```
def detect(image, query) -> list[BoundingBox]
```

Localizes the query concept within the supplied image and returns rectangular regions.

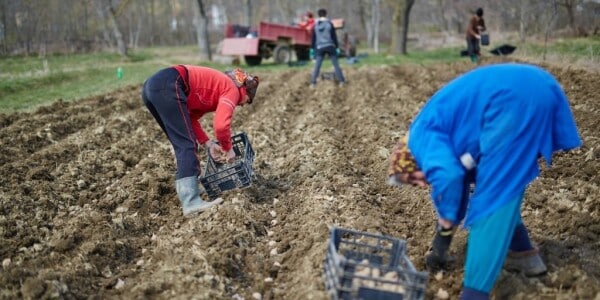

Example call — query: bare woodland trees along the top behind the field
[0,0,600,59]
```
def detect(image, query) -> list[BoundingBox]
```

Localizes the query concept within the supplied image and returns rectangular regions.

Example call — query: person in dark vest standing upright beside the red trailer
[310,9,346,88]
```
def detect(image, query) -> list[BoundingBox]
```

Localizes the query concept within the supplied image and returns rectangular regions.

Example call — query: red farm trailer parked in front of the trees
[221,19,344,66]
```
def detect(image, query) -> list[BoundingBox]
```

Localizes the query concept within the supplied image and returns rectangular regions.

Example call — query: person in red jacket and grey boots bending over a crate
[142,65,259,216]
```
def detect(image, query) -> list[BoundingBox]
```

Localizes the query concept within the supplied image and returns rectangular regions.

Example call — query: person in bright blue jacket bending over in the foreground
[388,63,582,299]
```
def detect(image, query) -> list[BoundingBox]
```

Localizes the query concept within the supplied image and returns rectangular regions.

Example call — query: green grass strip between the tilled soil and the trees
[0,37,600,113]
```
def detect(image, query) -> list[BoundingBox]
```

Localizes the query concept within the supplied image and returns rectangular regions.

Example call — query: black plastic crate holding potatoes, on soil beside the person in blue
[323,227,428,300]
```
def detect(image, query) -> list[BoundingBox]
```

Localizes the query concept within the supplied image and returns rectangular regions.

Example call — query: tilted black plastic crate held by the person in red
[200,132,254,199]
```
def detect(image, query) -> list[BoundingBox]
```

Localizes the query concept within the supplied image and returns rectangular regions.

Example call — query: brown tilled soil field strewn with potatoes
[0,57,600,299]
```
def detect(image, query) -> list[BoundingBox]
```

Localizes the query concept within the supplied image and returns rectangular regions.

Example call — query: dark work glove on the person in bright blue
[425,224,455,272]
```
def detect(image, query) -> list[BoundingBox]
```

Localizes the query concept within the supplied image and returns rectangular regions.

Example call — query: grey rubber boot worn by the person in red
[175,176,223,216]
